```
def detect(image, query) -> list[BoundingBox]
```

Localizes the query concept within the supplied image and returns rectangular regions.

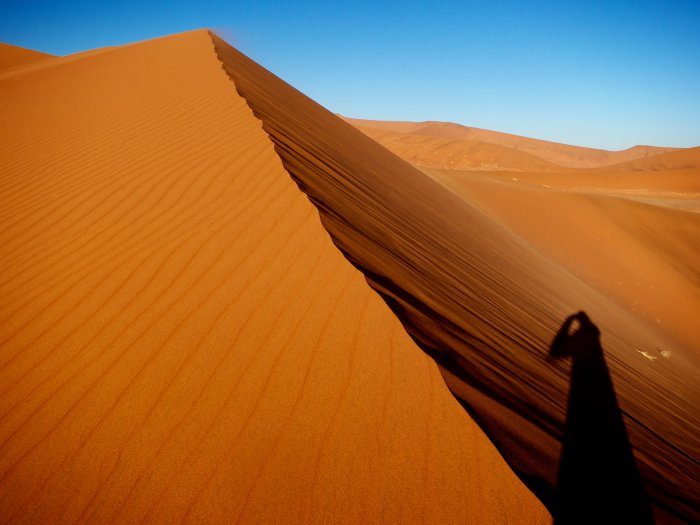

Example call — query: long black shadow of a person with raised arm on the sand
[550,312,654,525]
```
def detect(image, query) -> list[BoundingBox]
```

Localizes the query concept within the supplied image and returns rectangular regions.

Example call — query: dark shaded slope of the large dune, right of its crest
[214,38,699,519]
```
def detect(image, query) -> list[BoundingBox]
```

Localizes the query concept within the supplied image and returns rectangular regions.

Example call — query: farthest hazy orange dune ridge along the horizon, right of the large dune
[343,117,674,168]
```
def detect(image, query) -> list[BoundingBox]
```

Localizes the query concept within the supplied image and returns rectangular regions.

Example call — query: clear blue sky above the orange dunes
[0,0,700,149]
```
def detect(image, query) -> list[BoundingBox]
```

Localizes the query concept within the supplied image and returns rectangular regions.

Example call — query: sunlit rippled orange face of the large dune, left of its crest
[0,31,548,523]
